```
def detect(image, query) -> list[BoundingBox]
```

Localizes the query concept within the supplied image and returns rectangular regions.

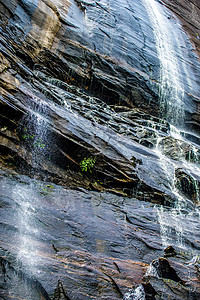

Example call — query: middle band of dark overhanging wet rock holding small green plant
[1,76,199,204]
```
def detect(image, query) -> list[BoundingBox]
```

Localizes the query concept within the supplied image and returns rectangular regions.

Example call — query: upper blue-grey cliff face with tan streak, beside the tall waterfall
[1,1,199,124]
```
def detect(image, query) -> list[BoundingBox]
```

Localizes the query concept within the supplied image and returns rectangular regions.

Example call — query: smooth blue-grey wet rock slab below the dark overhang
[0,172,200,299]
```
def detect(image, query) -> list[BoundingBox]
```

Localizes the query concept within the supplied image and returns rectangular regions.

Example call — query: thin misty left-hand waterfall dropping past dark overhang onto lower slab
[10,97,50,300]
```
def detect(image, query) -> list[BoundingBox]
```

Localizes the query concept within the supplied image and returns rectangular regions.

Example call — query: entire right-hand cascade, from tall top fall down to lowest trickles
[143,0,200,248]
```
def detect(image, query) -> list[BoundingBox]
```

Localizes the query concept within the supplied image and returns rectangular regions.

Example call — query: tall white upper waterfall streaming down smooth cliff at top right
[144,0,191,126]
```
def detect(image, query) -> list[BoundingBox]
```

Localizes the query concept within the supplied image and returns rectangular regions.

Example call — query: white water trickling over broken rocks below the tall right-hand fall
[155,128,200,249]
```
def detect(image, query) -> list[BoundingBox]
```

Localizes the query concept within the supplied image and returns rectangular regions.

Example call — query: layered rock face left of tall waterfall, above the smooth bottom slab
[1,1,199,203]
